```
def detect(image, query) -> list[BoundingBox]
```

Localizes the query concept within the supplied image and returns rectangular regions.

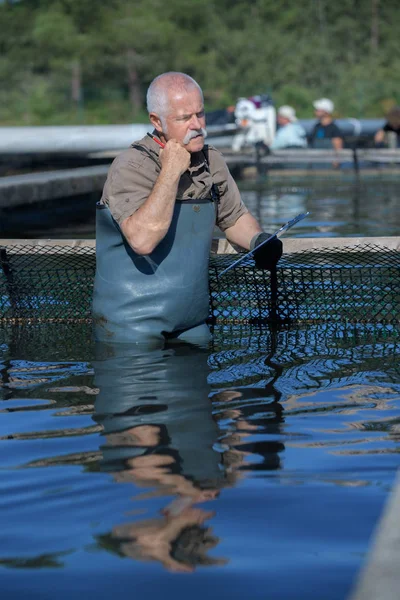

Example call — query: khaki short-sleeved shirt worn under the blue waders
[100,135,248,231]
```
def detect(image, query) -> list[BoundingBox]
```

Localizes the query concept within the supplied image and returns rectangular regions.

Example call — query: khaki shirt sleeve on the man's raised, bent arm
[101,149,158,225]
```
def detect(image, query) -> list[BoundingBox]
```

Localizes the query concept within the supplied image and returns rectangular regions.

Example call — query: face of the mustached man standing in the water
[163,88,206,152]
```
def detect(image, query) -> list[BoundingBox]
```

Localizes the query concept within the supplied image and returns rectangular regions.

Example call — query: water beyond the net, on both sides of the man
[0,171,400,238]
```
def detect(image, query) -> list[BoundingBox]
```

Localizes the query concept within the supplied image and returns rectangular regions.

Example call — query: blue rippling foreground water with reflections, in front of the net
[0,325,400,600]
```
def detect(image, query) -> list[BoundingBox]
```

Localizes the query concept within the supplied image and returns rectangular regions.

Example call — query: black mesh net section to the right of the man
[210,244,400,323]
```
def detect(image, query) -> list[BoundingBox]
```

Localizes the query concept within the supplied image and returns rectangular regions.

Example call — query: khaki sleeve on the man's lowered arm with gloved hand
[209,147,248,231]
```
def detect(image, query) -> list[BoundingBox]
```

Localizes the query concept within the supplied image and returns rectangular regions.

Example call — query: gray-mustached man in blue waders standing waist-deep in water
[93,72,282,344]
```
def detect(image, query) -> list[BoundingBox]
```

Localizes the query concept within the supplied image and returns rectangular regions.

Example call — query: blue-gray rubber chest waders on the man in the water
[93,146,218,343]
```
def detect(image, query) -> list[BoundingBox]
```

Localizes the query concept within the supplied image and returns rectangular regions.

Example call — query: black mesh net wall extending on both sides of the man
[0,243,400,324]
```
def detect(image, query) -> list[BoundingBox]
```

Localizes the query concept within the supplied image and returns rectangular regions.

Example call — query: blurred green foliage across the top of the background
[0,0,400,125]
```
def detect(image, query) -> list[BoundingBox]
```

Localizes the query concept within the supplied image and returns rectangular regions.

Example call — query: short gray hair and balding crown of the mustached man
[146,71,203,117]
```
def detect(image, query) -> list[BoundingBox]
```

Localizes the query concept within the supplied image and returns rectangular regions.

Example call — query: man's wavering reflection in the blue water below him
[94,345,283,572]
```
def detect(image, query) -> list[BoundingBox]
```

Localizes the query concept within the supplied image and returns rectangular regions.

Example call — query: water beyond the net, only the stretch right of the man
[241,174,400,237]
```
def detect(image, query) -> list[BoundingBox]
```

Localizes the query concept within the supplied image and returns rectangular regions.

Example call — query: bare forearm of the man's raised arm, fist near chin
[121,169,180,254]
